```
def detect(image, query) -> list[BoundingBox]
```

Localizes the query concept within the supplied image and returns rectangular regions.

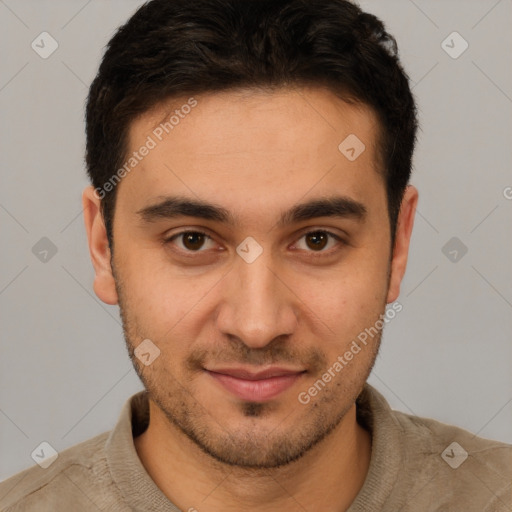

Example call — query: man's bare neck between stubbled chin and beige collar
[134,400,371,512]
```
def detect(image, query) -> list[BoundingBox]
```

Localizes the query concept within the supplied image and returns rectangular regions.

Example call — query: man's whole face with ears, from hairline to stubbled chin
[84,89,412,467]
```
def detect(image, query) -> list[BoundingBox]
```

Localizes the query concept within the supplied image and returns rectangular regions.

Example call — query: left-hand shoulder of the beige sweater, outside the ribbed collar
[0,432,127,512]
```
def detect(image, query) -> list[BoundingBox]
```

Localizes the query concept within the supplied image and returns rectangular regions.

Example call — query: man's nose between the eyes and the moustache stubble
[217,252,297,348]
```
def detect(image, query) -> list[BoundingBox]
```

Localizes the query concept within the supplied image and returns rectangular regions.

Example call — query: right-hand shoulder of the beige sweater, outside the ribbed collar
[391,411,512,511]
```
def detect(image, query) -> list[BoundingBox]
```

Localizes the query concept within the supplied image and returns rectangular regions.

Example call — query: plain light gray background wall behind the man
[0,0,512,480]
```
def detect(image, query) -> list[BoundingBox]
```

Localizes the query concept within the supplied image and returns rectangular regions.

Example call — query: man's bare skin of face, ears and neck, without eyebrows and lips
[83,88,418,512]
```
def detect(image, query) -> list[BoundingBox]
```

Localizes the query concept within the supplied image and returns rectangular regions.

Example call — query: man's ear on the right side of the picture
[386,185,418,304]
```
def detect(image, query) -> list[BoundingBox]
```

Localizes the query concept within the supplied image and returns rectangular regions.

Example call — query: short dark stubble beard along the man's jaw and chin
[116,270,385,470]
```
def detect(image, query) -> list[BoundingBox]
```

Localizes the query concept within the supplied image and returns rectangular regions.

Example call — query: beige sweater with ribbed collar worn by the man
[0,384,512,512]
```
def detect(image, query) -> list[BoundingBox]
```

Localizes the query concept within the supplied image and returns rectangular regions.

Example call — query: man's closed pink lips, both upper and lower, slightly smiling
[206,367,305,402]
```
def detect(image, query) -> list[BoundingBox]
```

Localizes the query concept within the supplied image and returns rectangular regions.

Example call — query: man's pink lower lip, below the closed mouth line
[208,372,302,402]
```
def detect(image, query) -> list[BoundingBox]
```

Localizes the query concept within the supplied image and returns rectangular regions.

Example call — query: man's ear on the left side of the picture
[82,187,117,305]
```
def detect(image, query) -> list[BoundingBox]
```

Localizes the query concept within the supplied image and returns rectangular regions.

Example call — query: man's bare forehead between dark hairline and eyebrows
[121,88,383,216]
